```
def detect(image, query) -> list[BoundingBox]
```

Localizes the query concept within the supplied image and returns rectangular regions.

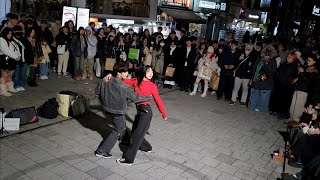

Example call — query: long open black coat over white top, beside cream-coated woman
[177,47,197,81]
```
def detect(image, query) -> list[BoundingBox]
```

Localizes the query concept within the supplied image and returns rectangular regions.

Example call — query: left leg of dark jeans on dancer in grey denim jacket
[97,114,126,153]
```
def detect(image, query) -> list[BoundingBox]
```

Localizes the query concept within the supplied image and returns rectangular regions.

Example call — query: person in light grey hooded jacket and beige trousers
[83,26,98,80]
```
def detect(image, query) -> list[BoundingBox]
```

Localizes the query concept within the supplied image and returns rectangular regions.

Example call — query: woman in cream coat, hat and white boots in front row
[189,46,220,97]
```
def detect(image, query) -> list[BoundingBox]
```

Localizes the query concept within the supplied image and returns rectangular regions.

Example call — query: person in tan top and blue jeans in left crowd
[39,38,52,80]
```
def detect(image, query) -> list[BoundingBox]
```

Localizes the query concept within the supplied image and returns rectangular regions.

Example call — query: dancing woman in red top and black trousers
[107,66,167,165]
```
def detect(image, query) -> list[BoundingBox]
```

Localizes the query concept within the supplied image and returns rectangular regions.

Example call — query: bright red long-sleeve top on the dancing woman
[122,78,167,119]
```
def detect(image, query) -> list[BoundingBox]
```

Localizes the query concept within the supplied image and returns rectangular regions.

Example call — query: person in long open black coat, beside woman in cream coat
[177,38,196,92]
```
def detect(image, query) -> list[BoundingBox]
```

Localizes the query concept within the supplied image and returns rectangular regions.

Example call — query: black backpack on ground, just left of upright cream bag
[38,98,59,119]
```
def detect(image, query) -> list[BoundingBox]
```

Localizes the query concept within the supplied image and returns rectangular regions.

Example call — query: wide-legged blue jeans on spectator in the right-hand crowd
[248,88,271,112]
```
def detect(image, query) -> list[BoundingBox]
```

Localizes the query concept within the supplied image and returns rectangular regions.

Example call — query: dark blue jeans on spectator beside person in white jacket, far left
[13,63,28,87]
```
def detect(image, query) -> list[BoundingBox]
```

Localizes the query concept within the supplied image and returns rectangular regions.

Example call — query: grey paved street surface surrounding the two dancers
[0,74,285,180]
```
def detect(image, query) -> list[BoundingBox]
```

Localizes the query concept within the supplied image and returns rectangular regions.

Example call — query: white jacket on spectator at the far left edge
[0,37,21,61]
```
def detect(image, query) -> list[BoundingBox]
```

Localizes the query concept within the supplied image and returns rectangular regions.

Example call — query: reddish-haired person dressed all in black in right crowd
[269,52,299,120]
